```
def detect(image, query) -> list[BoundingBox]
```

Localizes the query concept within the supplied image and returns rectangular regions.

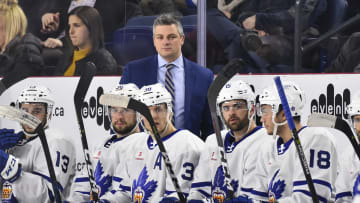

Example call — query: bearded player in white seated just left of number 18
[191,80,268,203]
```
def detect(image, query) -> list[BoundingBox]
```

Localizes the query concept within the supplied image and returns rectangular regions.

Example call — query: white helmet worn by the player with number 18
[260,81,305,117]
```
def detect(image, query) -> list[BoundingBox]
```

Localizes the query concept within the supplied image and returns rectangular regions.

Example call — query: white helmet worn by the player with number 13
[16,85,55,128]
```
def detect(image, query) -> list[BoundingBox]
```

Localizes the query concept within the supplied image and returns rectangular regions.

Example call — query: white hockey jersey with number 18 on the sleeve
[252,127,338,203]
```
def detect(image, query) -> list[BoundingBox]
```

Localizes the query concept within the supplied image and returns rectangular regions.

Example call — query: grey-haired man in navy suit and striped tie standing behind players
[120,14,213,139]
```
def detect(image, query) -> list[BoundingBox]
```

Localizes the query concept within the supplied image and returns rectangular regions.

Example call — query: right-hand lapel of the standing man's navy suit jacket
[184,58,196,129]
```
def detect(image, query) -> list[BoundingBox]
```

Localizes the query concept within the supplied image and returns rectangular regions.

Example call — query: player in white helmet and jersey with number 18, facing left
[250,82,337,203]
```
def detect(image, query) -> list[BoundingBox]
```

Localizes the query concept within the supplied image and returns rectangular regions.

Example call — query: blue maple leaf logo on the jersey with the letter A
[132,166,157,203]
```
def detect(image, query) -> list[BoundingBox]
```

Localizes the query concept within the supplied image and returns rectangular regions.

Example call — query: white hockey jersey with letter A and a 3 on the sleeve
[109,130,204,203]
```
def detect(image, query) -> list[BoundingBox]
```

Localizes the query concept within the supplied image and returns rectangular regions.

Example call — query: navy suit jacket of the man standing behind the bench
[120,55,214,139]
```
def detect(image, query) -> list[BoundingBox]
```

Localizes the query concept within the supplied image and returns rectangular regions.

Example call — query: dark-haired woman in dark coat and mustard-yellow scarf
[55,6,118,76]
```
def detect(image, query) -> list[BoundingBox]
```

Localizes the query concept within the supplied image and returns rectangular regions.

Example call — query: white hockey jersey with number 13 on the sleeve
[3,129,75,203]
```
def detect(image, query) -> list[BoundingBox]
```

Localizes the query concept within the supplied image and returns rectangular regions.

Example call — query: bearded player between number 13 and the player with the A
[69,83,140,202]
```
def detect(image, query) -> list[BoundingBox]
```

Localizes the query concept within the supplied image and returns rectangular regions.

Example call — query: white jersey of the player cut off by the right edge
[335,146,360,203]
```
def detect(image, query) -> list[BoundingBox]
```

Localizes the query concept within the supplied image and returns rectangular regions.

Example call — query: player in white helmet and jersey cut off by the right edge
[336,92,360,203]
